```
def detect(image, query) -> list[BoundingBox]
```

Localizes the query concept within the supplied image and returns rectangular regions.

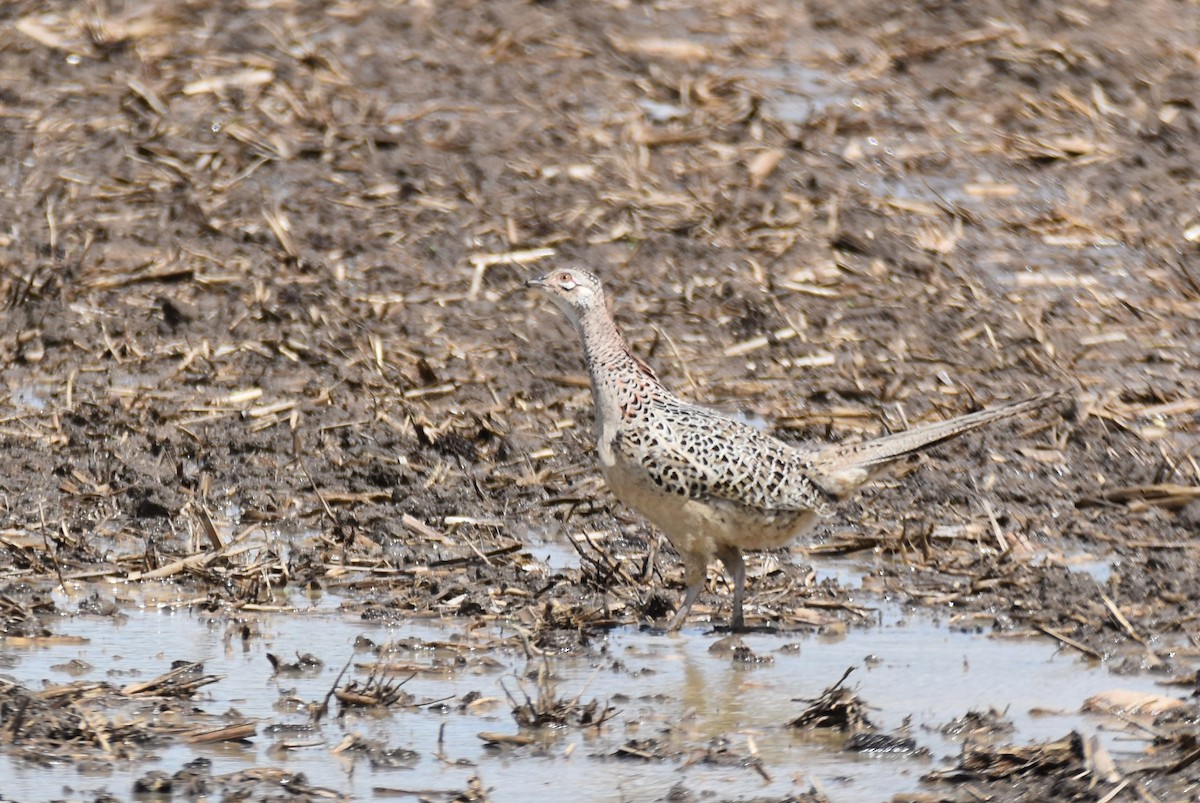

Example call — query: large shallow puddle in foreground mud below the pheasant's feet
[0,597,1156,801]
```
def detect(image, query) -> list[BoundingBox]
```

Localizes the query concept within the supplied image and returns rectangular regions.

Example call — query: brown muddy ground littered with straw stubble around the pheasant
[0,0,1200,801]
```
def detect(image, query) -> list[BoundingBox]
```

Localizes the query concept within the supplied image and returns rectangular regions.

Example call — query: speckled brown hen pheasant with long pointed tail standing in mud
[528,269,1057,629]
